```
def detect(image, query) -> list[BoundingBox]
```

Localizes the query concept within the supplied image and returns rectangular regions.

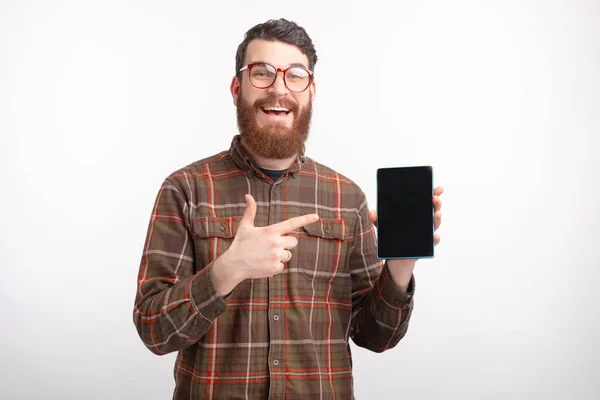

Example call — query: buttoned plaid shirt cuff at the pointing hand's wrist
[189,262,227,322]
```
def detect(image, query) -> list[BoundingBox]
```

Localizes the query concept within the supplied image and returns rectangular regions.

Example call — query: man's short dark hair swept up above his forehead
[235,18,317,79]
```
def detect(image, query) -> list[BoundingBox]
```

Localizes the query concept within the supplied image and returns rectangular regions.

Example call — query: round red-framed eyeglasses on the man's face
[240,63,313,93]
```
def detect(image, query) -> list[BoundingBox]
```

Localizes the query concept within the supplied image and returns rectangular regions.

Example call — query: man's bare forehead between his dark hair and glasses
[244,39,308,68]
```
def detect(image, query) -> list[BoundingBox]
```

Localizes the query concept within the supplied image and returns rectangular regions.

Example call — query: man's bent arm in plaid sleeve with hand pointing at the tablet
[133,189,319,354]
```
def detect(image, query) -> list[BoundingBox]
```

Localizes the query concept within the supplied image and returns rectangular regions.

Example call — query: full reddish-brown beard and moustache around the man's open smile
[236,92,312,160]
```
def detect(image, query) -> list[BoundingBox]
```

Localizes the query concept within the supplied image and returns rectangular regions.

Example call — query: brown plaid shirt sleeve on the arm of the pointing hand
[133,179,227,354]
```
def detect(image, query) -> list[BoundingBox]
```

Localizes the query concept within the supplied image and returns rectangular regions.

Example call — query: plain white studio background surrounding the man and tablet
[0,0,600,400]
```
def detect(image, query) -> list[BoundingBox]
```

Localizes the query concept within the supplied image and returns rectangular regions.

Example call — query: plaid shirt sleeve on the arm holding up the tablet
[349,194,415,353]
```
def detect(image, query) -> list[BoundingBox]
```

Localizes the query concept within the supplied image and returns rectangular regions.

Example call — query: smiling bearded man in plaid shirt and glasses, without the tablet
[134,19,442,399]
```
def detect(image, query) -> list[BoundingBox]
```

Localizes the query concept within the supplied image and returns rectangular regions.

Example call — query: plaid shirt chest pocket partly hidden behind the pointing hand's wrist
[192,217,242,270]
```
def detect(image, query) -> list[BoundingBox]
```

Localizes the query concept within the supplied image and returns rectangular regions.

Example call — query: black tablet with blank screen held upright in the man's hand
[377,166,433,259]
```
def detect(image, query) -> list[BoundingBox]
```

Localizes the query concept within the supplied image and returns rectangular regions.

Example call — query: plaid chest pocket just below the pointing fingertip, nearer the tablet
[298,219,353,281]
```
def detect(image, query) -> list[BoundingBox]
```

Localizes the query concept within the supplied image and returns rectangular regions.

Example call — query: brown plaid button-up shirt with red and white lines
[133,136,414,400]
